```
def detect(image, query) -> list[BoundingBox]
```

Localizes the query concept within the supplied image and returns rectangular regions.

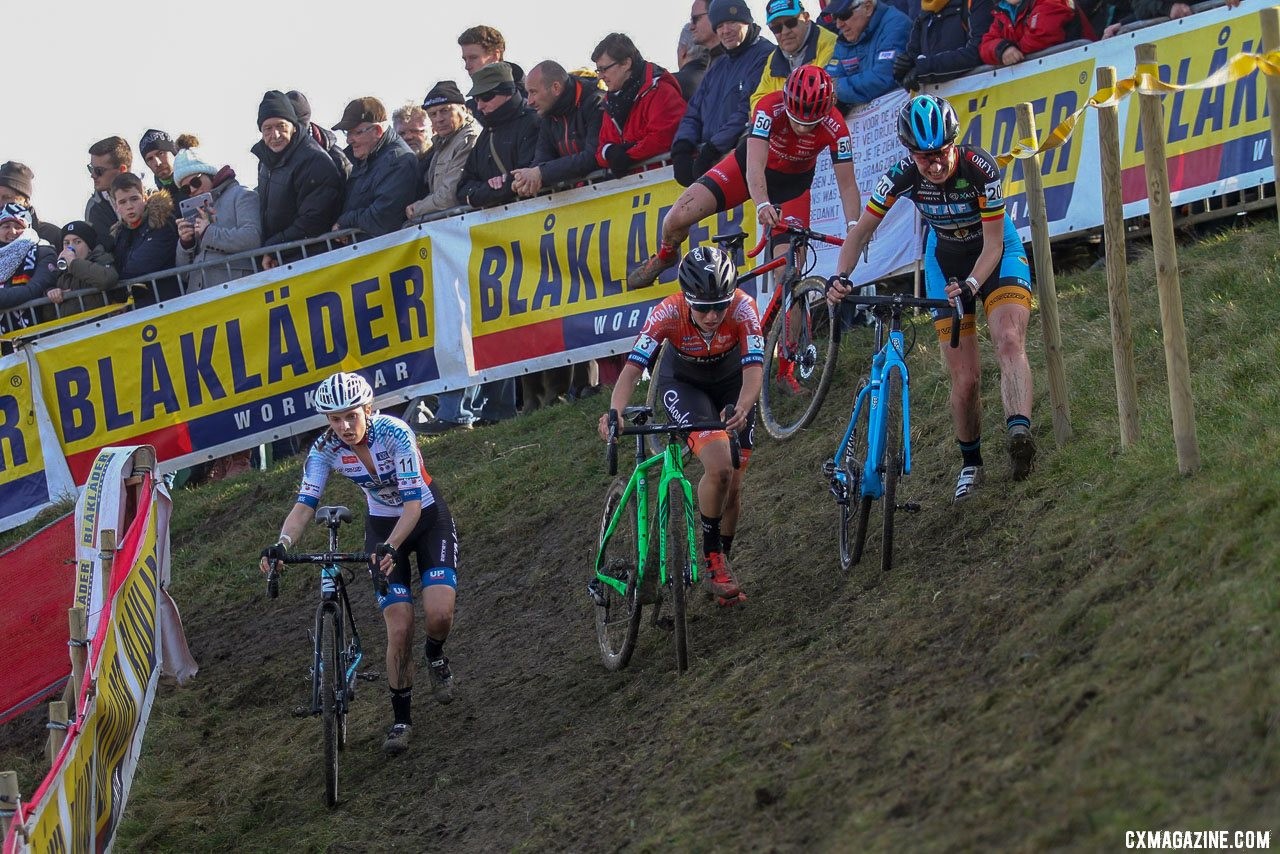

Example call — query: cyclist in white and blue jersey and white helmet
[261,373,458,755]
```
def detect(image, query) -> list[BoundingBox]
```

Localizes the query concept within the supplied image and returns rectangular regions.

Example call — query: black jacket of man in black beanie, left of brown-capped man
[251,132,343,246]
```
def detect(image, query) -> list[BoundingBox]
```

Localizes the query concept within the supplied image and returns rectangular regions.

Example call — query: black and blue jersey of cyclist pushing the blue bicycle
[867,145,1005,246]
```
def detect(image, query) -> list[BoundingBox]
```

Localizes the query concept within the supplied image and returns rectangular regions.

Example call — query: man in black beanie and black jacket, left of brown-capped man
[252,90,343,270]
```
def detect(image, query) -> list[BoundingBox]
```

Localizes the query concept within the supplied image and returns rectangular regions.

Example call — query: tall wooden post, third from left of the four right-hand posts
[1134,44,1199,475]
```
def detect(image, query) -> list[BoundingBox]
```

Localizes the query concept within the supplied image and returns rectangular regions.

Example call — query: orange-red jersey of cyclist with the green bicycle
[627,291,764,383]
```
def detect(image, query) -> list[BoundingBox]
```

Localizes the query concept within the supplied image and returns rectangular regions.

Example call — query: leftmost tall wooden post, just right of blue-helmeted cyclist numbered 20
[1015,101,1071,446]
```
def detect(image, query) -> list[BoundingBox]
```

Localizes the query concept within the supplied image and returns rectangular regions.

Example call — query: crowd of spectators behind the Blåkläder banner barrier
[0,0,1238,429]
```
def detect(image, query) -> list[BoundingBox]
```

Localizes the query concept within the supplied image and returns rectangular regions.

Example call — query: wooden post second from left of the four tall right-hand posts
[1097,65,1139,448]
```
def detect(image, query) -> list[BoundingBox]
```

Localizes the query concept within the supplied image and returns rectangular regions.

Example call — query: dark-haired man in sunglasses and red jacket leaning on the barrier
[591,32,686,175]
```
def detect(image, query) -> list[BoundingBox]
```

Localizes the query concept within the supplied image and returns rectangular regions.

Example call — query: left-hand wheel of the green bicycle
[593,478,644,670]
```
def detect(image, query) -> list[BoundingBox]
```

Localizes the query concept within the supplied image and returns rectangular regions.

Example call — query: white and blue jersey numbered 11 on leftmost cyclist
[298,414,433,516]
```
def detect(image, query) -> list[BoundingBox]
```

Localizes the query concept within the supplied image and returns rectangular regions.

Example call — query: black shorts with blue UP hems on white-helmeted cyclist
[365,483,458,608]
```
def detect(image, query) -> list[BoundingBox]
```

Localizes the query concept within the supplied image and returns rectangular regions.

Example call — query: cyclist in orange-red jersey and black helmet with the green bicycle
[600,247,764,606]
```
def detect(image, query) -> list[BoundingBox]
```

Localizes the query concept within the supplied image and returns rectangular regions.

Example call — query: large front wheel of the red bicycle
[760,275,838,439]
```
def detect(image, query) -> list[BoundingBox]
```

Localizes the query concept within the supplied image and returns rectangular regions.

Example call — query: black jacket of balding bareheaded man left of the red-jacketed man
[534,74,604,187]
